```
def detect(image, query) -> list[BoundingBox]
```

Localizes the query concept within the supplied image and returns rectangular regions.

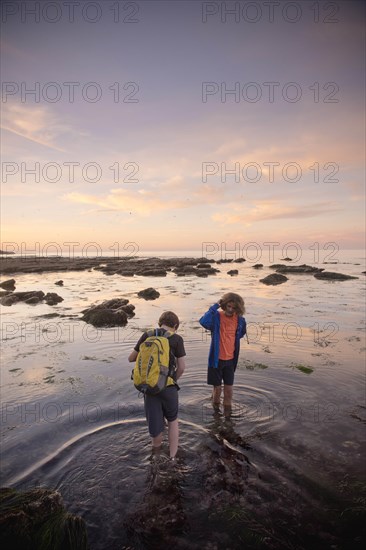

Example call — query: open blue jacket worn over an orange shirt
[199,304,247,369]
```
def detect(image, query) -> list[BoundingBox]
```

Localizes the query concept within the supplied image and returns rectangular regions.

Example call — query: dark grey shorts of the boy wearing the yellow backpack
[145,386,178,437]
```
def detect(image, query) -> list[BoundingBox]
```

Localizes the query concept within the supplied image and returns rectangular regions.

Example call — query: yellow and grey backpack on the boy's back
[132,329,174,395]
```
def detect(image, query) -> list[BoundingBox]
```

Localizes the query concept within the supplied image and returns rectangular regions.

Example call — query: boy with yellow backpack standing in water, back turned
[128,311,186,460]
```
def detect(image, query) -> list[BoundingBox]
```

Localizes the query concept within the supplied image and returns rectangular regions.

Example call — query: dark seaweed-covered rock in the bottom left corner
[0,488,89,550]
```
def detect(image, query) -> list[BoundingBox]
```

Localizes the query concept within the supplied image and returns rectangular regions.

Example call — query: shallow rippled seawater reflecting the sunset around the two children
[1,253,366,550]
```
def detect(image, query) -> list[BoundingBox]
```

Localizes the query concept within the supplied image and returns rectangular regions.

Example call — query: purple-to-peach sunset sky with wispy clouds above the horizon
[1,0,365,253]
